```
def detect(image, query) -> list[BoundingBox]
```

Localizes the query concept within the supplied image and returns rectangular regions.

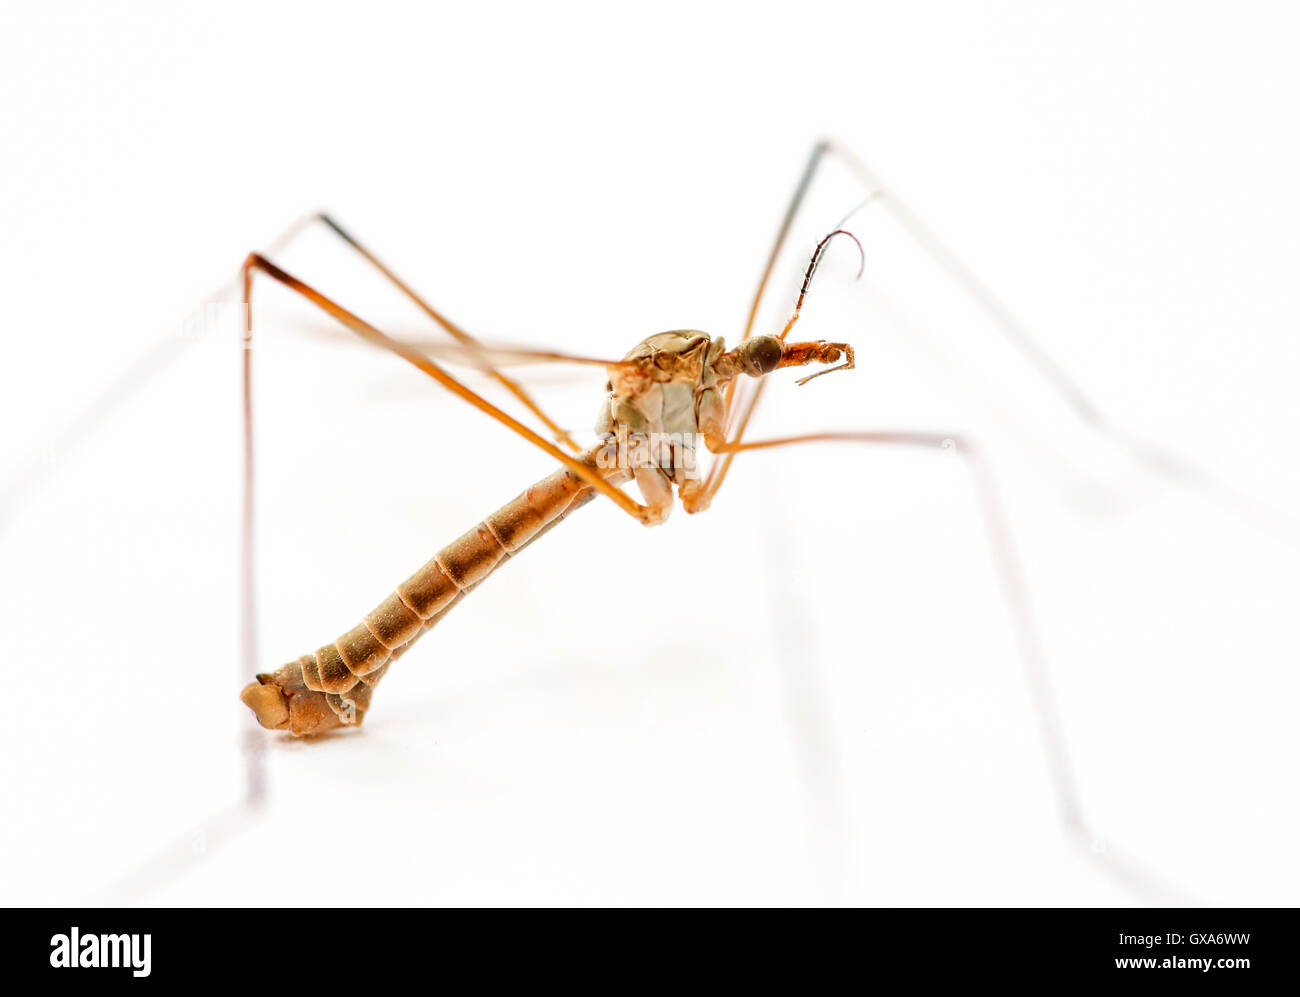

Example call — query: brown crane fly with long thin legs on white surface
[228,143,1201,894]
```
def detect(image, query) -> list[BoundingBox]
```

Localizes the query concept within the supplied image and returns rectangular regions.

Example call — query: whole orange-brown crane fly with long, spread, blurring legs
[17,143,1279,904]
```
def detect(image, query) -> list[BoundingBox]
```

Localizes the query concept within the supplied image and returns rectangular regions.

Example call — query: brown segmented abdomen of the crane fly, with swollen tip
[239,451,608,734]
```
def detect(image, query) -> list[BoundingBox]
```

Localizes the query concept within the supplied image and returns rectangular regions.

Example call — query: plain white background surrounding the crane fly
[0,3,1300,905]
